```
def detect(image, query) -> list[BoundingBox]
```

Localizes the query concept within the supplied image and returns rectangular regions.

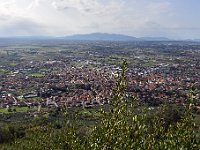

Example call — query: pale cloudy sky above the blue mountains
[0,0,200,39]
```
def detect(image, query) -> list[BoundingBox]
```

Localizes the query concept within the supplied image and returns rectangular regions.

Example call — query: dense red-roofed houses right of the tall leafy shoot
[128,64,200,105]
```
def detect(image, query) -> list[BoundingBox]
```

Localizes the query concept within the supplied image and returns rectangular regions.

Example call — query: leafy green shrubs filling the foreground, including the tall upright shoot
[0,61,200,150]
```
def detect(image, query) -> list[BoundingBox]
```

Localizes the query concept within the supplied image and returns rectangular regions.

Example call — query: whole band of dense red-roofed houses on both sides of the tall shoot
[0,57,200,110]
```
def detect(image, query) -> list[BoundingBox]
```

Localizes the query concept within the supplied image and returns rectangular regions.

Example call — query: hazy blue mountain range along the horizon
[0,33,200,42]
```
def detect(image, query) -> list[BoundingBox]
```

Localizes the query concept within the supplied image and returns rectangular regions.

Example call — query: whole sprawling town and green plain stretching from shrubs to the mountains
[0,40,200,112]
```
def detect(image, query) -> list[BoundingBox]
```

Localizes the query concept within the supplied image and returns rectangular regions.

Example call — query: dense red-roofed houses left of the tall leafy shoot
[0,62,117,111]
